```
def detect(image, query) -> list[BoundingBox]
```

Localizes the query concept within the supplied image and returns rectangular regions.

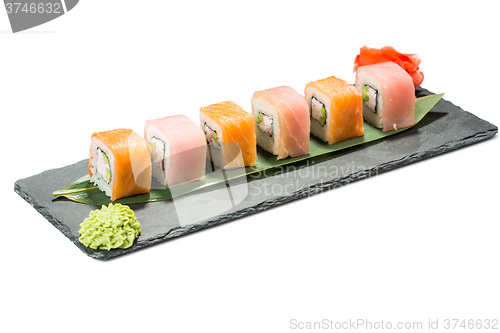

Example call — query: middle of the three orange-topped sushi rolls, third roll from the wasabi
[200,101,257,169]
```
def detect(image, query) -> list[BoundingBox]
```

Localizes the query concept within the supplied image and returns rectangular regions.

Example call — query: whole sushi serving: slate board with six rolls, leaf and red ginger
[15,47,498,259]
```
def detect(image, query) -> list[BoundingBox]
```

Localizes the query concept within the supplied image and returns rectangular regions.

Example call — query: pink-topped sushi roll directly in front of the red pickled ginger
[356,62,416,132]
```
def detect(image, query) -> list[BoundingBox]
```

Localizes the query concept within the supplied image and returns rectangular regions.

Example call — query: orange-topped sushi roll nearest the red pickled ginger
[305,76,364,145]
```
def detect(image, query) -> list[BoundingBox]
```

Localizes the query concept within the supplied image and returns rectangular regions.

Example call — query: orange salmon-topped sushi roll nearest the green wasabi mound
[89,129,151,201]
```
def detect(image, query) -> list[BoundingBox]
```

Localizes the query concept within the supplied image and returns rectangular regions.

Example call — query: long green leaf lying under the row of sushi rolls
[52,94,444,205]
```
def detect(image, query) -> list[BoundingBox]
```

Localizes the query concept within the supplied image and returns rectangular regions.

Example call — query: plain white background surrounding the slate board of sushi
[0,0,500,332]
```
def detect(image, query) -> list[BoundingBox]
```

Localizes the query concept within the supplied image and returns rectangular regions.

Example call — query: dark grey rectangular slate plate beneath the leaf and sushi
[14,88,498,259]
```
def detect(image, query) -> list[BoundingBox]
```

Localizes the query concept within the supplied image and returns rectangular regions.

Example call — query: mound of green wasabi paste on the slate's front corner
[78,203,141,251]
